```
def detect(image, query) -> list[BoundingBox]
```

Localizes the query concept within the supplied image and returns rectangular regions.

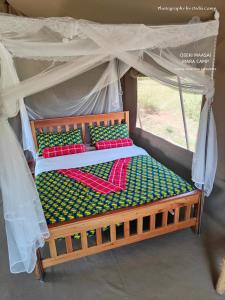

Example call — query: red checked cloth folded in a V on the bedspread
[57,157,131,194]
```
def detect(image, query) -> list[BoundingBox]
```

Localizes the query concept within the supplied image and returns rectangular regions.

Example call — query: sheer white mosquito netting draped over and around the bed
[0,13,219,273]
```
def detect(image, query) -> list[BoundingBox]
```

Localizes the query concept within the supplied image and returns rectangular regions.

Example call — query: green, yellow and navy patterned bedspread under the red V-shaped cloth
[36,155,195,224]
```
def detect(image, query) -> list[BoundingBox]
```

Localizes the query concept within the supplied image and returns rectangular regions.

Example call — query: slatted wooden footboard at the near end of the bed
[36,191,201,278]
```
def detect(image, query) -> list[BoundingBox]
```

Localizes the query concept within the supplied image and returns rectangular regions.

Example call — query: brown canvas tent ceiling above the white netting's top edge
[8,0,216,24]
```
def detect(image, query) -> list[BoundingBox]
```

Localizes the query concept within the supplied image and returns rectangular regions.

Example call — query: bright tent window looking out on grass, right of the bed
[137,77,202,151]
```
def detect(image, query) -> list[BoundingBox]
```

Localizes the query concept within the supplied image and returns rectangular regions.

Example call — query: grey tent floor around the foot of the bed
[0,182,225,300]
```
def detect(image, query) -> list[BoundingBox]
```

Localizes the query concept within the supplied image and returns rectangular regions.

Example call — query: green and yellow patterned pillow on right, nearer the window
[89,123,129,145]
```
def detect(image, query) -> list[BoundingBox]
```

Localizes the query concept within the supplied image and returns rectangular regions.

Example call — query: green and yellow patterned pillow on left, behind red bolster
[37,129,83,155]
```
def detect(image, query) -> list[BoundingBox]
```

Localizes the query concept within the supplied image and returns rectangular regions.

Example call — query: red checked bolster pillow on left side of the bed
[42,144,86,158]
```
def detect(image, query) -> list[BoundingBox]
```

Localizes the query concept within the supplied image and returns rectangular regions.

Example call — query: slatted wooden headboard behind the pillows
[31,111,129,150]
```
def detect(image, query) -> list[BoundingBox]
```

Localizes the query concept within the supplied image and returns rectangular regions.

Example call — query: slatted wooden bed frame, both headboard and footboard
[31,111,202,280]
